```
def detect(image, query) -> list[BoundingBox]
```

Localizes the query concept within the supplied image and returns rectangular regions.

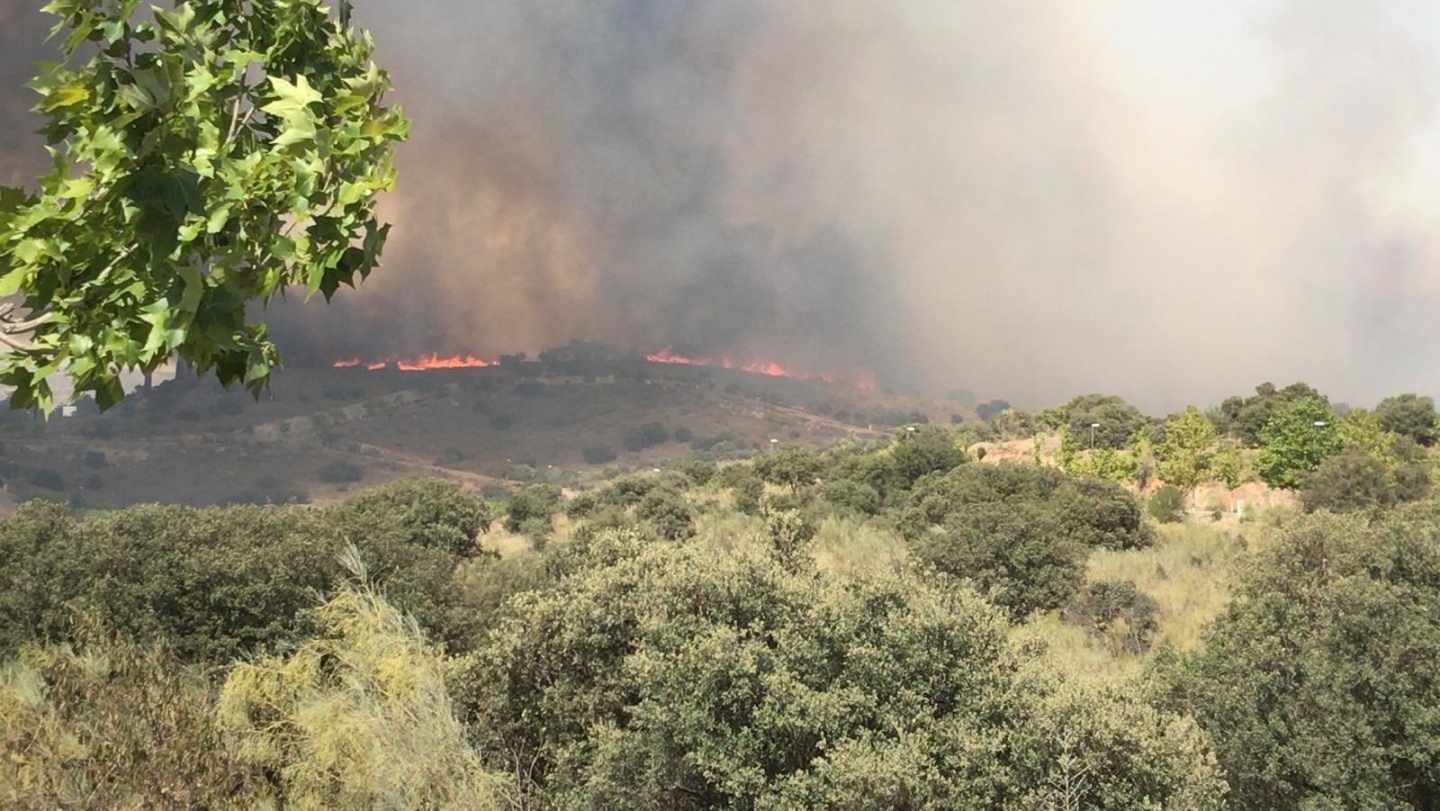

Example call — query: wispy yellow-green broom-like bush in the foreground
[216,576,500,810]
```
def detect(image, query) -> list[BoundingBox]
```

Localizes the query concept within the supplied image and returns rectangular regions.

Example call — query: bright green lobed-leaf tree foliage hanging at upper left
[0,0,409,411]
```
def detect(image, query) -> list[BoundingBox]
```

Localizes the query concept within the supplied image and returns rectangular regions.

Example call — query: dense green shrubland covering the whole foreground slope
[8,387,1440,810]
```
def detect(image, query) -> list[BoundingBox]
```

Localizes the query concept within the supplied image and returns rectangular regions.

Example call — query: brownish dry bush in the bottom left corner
[0,637,269,808]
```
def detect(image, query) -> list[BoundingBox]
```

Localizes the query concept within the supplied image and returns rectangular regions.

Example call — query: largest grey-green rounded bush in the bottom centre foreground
[455,533,1223,811]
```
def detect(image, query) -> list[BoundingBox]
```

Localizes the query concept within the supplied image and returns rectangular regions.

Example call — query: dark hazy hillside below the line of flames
[0,363,953,510]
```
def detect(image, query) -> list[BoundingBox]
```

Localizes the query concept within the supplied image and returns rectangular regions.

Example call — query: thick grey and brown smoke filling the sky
[0,0,1440,409]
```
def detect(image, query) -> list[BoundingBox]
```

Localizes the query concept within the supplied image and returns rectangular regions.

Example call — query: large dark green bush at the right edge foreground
[1155,504,1440,808]
